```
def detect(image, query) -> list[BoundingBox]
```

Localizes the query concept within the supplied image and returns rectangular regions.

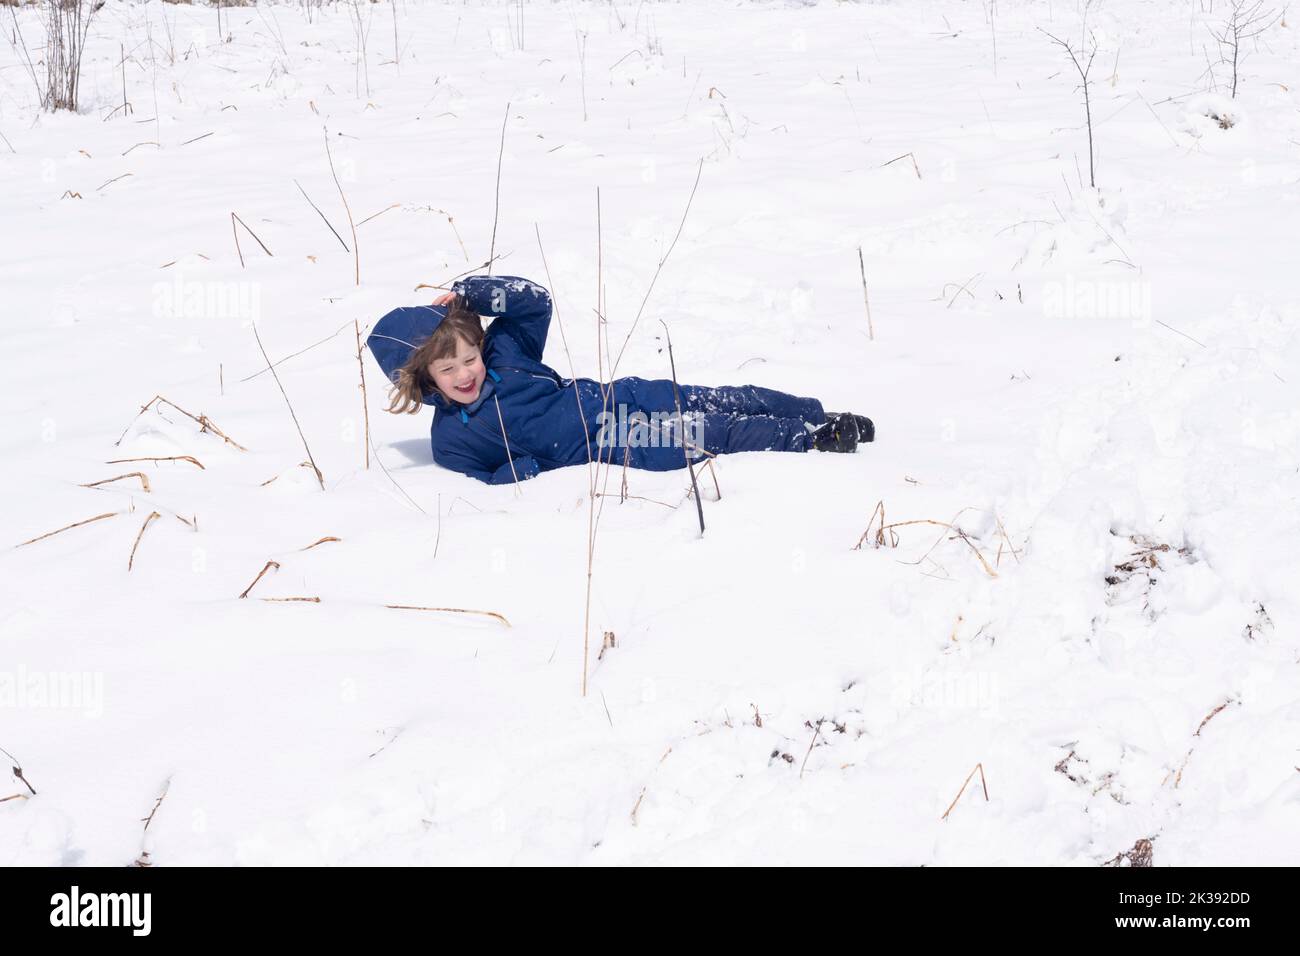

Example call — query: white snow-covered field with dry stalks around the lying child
[0,0,1300,866]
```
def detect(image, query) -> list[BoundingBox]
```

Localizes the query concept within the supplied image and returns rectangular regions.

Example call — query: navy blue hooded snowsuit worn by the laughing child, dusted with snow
[367,276,826,484]
